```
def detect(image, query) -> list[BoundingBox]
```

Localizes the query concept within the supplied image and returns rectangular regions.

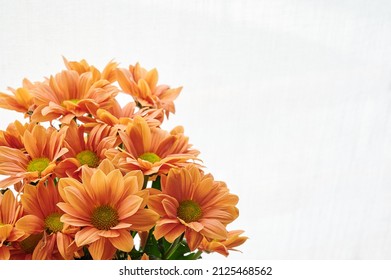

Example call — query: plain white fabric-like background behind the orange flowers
[0,0,391,259]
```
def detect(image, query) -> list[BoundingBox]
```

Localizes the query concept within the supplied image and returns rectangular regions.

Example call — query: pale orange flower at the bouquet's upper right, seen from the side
[117,63,182,117]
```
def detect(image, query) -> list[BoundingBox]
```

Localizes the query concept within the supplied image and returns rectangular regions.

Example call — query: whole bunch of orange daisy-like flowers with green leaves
[0,59,247,259]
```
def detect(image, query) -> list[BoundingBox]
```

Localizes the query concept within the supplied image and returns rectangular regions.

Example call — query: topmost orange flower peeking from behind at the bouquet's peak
[63,57,118,83]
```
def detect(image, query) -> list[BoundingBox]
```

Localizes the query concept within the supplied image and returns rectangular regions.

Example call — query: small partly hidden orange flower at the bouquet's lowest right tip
[198,230,248,257]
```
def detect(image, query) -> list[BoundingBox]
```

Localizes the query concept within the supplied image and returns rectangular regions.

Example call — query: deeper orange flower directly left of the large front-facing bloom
[16,180,77,260]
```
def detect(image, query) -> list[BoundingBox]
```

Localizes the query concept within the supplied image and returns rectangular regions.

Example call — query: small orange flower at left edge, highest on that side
[0,79,35,117]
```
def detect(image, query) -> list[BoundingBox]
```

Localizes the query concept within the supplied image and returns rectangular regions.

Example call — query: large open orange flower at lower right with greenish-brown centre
[148,165,239,251]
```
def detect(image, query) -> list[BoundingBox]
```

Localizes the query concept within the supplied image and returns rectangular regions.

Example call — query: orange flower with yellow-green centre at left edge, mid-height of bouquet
[0,125,68,188]
